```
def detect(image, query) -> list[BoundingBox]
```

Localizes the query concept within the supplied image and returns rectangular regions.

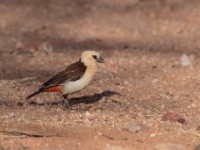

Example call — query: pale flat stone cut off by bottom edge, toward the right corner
[154,143,185,150]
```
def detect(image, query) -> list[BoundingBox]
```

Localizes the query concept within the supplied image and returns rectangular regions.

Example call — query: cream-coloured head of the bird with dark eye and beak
[81,51,104,66]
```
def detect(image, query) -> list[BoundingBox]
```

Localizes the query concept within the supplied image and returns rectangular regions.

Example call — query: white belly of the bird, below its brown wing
[62,74,92,95]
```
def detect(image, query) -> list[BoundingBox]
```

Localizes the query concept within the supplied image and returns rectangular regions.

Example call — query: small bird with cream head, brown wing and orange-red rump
[26,50,105,108]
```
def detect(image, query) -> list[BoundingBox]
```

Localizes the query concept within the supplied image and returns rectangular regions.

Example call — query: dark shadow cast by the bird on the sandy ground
[30,91,121,106]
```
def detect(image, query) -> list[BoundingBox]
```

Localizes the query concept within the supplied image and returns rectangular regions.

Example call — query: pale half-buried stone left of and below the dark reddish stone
[127,120,149,133]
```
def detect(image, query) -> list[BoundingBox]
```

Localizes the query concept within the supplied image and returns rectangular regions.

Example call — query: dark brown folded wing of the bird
[41,61,86,89]
